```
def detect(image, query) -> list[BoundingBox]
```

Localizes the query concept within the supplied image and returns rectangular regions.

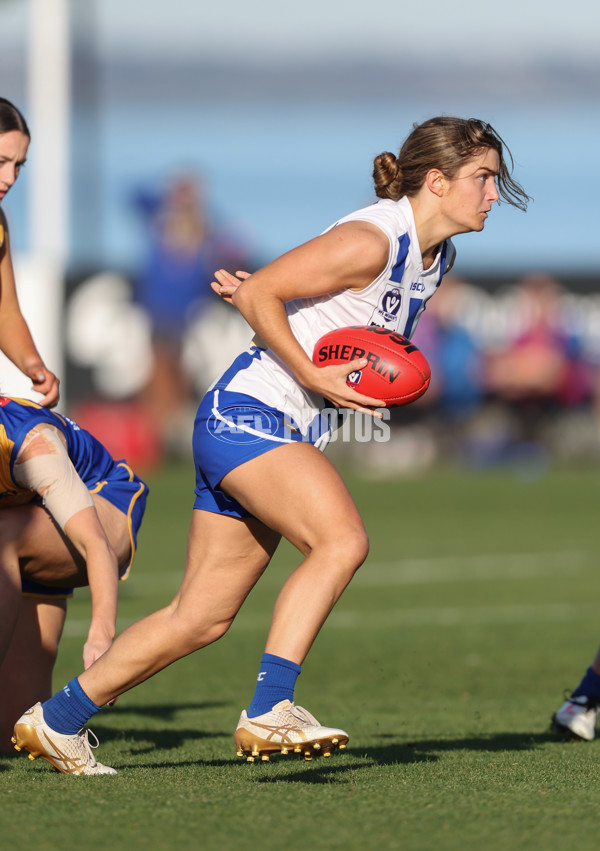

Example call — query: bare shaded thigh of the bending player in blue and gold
[0,505,87,587]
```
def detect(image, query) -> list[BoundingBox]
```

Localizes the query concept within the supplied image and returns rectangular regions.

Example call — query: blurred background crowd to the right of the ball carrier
[382,272,600,473]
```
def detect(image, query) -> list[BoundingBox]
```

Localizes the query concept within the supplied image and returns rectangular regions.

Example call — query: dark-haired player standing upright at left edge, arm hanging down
[0,98,59,408]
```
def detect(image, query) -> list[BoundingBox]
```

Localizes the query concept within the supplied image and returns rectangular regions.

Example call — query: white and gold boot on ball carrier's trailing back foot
[12,703,117,774]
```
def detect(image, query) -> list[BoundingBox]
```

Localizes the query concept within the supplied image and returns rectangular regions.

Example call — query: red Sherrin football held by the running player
[313,325,431,408]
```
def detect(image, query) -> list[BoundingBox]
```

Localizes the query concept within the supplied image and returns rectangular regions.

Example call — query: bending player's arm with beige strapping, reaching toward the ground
[13,425,119,668]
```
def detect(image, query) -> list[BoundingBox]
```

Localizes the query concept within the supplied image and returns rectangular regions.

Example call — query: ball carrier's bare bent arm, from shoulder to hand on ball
[225,221,389,414]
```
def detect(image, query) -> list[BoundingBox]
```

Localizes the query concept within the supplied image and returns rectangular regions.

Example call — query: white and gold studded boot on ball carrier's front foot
[233,700,348,762]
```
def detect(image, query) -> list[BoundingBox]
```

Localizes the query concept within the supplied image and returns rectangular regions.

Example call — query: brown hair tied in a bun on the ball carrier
[373,116,531,210]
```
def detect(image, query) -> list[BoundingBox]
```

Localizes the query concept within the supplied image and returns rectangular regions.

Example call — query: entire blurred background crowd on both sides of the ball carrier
[62,169,600,475]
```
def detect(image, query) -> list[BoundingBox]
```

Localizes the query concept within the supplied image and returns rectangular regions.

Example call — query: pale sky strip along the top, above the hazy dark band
[0,0,600,64]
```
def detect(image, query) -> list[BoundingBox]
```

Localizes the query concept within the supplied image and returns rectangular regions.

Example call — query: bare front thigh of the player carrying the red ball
[220,442,366,552]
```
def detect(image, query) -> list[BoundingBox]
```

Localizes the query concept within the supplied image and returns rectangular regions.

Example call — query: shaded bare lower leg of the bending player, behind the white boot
[0,596,67,751]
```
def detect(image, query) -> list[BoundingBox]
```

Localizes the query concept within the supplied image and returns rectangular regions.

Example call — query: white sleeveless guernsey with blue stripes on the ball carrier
[221,197,455,431]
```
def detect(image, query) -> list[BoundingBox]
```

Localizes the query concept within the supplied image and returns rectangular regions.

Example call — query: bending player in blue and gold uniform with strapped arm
[0,396,148,749]
